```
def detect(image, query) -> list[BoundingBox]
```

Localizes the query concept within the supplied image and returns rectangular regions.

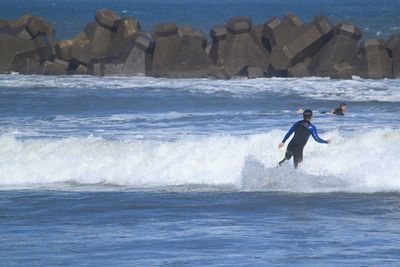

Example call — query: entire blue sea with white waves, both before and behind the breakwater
[0,0,400,267]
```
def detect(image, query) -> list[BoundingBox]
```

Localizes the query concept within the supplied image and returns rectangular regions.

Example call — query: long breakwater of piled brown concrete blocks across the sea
[0,9,400,79]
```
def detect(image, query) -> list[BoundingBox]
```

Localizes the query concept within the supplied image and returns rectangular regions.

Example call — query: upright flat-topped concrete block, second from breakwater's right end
[359,39,392,79]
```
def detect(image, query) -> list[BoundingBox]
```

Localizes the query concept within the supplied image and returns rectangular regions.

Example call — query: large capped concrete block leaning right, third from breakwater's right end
[310,23,362,77]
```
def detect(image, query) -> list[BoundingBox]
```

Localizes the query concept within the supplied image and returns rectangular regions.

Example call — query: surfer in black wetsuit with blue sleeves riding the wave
[279,109,331,169]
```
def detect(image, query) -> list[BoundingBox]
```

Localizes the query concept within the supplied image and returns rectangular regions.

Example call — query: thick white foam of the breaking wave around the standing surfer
[0,129,400,192]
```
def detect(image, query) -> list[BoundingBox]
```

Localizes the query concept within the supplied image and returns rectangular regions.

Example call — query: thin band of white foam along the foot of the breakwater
[0,75,400,102]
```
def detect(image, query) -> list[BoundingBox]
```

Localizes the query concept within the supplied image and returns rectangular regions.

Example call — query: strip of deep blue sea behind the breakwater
[0,0,400,38]
